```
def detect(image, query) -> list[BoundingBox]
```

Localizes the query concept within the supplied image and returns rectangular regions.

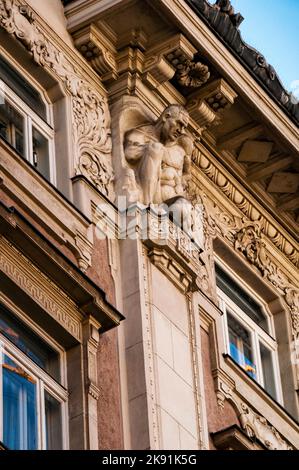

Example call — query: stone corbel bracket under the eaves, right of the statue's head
[186,78,238,130]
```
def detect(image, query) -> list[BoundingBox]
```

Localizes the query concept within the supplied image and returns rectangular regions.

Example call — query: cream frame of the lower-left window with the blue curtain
[0,296,69,450]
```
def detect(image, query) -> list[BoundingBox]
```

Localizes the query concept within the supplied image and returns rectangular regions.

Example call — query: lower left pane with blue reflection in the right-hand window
[227,313,256,379]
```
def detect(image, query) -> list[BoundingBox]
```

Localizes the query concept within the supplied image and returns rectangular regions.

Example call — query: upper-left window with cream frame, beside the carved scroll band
[0,53,56,184]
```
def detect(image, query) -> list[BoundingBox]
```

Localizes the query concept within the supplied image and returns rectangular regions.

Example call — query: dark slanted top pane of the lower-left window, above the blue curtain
[0,304,60,381]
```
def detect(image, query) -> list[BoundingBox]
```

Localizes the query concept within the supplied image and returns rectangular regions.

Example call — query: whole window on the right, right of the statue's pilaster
[216,265,281,401]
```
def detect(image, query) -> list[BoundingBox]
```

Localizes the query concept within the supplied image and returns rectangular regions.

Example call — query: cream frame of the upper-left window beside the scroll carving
[0,74,57,186]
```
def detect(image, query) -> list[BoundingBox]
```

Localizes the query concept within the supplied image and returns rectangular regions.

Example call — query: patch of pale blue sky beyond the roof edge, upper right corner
[231,0,299,98]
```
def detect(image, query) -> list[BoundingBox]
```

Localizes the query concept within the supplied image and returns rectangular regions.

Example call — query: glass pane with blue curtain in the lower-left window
[2,356,38,450]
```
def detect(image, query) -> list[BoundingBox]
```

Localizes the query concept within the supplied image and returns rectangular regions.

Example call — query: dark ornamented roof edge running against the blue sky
[186,0,299,125]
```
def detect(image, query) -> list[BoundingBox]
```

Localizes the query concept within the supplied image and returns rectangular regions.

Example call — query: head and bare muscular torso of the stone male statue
[124,105,193,210]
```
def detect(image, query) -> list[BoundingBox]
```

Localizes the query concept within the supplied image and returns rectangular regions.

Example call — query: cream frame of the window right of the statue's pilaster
[216,260,283,405]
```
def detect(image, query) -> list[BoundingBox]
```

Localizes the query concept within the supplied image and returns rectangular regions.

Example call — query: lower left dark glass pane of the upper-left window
[0,98,25,156]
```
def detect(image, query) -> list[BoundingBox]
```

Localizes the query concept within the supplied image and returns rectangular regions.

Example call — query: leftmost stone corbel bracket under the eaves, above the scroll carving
[73,24,118,82]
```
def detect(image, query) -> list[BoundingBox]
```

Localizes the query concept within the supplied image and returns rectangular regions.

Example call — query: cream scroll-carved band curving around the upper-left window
[0,0,113,196]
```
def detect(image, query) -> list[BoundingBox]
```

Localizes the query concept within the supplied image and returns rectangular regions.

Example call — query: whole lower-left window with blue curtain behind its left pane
[0,304,67,450]
